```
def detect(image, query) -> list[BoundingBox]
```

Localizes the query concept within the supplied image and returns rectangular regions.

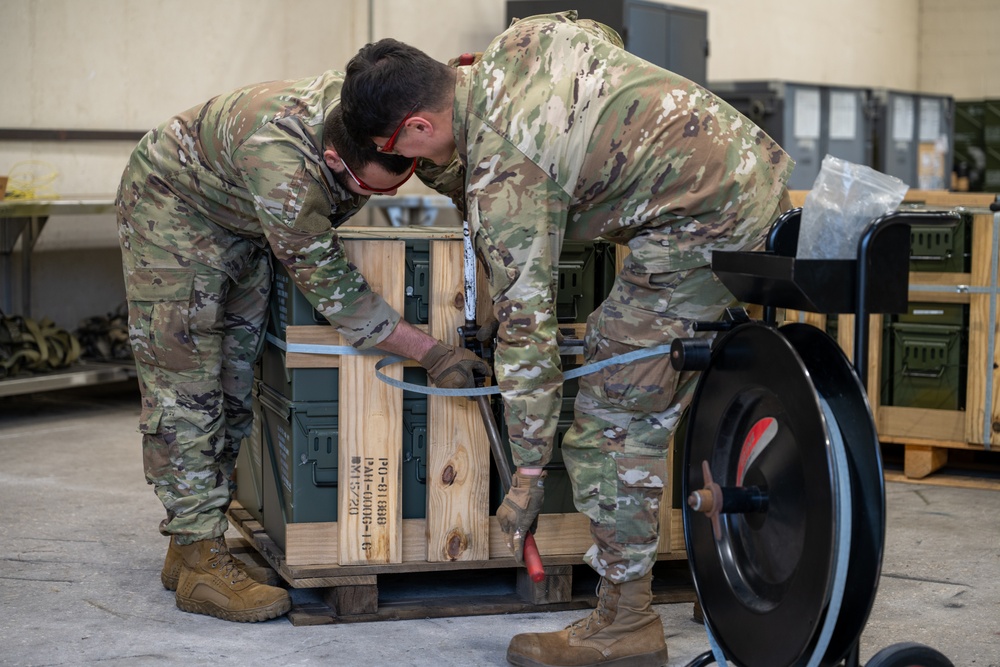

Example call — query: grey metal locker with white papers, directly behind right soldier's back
[709,81,872,190]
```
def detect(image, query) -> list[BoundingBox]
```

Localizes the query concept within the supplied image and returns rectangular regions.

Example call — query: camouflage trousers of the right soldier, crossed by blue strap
[562,259,735,583]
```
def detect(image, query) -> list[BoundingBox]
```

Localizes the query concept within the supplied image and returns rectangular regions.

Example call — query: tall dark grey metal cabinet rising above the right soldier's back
[507,0,708,86]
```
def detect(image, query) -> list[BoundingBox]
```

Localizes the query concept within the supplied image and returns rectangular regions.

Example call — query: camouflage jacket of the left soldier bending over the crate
[118,71,399,348]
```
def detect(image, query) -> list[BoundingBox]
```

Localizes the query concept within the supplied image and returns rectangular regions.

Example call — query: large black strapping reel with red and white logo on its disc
[682,323,885,667]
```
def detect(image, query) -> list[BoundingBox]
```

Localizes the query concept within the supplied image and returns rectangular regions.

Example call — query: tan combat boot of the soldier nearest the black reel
[507,574,667,667]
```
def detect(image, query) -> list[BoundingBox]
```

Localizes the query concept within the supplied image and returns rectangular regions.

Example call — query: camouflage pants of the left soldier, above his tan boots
[119,217,271,544]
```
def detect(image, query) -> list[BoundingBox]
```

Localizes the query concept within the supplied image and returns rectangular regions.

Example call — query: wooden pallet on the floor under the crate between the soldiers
[229,503,696,626]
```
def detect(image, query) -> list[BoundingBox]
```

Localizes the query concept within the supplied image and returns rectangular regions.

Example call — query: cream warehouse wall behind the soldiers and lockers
[0,0,1000,326]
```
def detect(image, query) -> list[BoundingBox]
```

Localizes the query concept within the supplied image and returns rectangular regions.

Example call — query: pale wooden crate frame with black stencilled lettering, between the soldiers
[254,227,686,572]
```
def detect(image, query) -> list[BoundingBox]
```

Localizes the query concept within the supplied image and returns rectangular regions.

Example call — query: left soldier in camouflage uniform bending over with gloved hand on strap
[117,71,488,621]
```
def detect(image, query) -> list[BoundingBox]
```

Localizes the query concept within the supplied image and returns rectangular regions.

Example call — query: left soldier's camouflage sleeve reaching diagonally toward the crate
[234,137,400,349]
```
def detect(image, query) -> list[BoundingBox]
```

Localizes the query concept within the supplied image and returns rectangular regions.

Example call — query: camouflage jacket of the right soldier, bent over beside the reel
[422,12,794,463]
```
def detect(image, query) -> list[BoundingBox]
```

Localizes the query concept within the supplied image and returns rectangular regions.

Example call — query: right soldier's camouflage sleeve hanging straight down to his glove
[468,132,569,465]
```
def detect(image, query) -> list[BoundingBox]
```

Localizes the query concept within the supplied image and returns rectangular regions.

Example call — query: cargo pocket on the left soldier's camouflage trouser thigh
[125,269,199,371]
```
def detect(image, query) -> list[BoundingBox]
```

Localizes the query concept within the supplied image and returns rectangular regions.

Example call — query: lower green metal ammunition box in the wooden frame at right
[882,302,969,410]
